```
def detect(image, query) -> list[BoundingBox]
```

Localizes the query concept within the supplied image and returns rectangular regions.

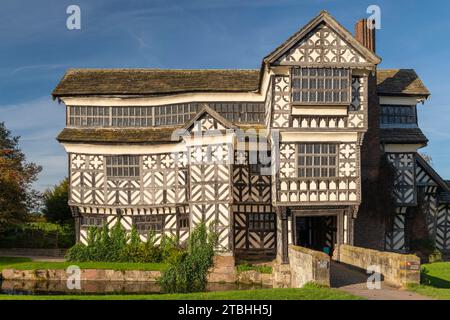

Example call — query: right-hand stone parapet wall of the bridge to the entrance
[335,245,420,287]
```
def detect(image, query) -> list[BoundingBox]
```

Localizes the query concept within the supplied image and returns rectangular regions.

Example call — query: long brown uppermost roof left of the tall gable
[52,69,259,98]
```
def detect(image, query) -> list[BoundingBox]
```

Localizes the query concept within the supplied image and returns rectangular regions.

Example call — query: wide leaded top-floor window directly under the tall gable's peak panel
[292,67,351,104]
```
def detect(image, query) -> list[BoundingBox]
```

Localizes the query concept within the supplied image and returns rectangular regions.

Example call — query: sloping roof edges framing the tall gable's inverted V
[263,10,381,64]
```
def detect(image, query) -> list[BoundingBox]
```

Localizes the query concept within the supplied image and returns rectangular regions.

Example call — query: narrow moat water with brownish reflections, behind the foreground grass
[0,280,264,295]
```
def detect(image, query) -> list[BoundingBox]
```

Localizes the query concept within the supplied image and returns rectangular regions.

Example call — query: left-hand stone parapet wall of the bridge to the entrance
[289,245,330,288]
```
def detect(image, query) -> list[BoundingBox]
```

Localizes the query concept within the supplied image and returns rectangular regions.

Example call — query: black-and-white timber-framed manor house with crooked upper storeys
[53,11,450,263]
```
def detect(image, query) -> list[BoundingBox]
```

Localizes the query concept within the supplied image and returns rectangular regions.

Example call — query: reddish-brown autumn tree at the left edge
[0,122,42,231]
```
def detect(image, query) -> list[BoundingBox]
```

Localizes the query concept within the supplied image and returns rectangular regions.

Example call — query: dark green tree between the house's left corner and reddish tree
[42,178,72,223]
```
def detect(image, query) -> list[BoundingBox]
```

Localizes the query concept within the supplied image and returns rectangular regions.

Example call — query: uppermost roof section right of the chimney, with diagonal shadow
[377,69,430,98]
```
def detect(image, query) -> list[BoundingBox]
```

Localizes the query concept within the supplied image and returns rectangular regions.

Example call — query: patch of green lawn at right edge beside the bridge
[409,262,450,300]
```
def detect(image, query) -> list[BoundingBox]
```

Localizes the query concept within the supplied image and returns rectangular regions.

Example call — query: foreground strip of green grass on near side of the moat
[0,285,363,300]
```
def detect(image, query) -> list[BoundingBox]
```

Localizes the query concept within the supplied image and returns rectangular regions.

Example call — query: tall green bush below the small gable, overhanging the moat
[159,223,217,293]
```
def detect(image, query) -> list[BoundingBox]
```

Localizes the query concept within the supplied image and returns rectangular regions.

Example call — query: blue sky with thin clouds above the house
[0,0,450,190]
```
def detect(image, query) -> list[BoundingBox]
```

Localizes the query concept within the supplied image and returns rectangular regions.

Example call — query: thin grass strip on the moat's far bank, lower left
[0,257,166,271]
